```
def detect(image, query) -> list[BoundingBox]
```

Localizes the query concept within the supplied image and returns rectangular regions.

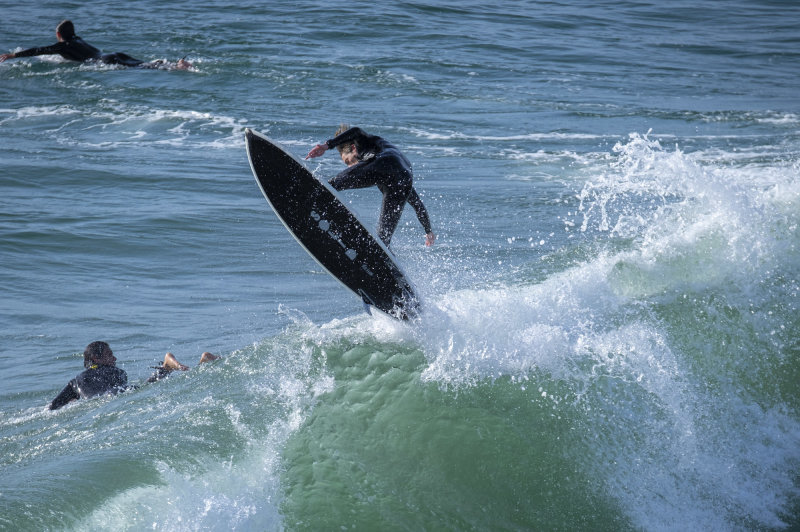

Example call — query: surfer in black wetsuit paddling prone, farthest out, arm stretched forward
[0,20,192,70]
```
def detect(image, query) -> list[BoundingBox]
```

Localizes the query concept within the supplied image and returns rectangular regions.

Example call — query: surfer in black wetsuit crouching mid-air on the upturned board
[306,124,436,247]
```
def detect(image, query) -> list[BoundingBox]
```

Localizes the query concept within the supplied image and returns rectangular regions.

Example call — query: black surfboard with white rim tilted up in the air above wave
[245,128,419,320]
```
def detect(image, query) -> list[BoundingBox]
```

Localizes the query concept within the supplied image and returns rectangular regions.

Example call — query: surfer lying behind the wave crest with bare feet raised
[49,342,219,410]
